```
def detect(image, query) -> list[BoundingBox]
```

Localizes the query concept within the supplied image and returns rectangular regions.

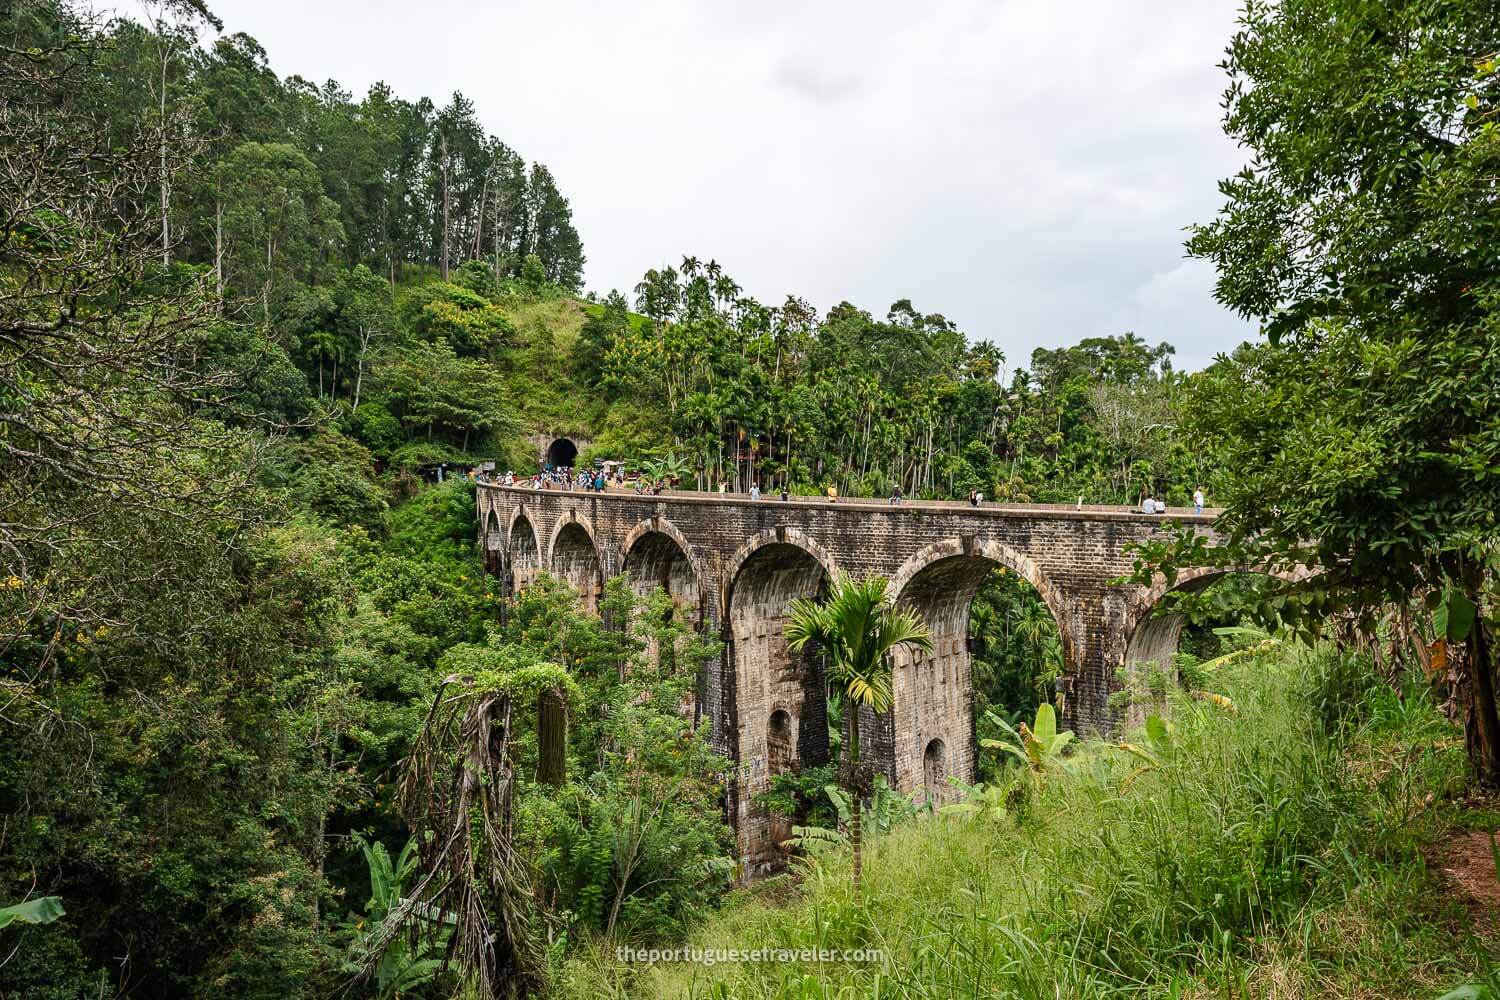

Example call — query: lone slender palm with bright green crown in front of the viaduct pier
[786,576,933,892]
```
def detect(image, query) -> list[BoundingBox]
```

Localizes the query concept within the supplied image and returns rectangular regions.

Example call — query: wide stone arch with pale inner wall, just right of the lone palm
[888,537,1073,801]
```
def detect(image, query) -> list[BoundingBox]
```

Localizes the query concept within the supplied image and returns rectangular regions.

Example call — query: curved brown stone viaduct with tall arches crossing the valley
[477,483,1248,873]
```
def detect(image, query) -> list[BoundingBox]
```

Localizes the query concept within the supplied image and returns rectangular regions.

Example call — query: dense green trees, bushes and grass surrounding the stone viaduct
[0,0,1500,1000]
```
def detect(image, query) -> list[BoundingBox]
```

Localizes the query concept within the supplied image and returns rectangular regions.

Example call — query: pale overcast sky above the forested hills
[152,0,1254,367]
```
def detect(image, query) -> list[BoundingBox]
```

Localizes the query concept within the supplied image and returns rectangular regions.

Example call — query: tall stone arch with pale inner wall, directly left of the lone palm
[723,528,837,873]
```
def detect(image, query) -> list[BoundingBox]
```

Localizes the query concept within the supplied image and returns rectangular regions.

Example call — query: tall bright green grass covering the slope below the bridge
[561,652,1481,1000]
